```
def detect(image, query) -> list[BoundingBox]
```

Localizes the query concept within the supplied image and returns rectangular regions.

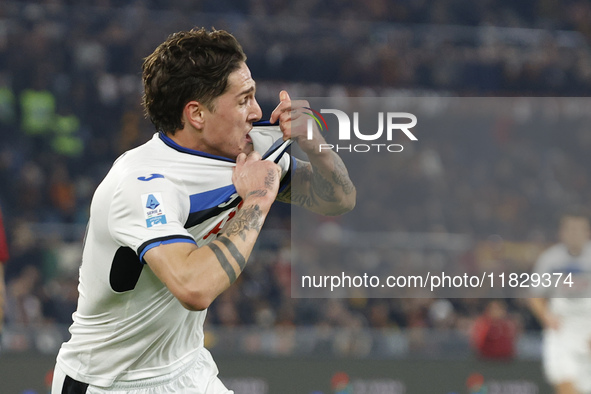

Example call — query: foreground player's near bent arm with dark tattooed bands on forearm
[144,152,281,310]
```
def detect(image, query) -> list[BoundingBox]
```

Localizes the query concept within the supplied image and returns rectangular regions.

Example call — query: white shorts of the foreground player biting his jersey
[51,350,234,394]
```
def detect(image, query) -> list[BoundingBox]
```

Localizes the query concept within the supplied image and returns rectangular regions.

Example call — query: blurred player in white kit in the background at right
[530,209,591,394]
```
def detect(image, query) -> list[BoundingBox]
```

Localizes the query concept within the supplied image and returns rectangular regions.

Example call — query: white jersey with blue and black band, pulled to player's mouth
[57,127,295,387]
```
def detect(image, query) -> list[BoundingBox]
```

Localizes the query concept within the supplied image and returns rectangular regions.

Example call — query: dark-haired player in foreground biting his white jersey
[52,29,356,394]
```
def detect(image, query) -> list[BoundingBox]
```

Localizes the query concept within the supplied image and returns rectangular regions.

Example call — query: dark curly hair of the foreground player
[142,28,246,134]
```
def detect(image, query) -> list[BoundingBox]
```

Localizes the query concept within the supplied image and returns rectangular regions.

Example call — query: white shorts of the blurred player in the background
[543,327,591,393]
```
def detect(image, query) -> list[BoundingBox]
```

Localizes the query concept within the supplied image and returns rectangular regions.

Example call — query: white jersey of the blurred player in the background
[533,242,591,324]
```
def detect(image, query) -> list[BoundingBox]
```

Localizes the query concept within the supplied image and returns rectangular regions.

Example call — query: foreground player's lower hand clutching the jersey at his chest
[232,152,281,208]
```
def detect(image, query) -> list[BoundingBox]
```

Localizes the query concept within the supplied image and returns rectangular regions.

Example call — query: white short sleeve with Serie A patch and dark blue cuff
[108,174,195,261]
